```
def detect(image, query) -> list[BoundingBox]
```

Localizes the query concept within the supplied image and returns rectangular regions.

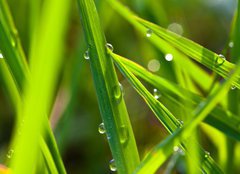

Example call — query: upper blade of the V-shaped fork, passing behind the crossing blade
[119,57,240,140]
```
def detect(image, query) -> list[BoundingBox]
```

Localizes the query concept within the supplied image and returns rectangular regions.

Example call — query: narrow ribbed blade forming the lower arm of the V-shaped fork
[111,53,222,173]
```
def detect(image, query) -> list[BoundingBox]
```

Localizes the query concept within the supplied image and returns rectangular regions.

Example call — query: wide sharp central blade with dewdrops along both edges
[78,0,139,174]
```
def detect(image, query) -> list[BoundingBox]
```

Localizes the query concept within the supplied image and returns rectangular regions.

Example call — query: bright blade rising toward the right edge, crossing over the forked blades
[135,58,240,173]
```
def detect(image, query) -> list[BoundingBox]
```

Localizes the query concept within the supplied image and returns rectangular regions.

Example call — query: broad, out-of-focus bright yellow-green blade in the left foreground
[11,0,70,174]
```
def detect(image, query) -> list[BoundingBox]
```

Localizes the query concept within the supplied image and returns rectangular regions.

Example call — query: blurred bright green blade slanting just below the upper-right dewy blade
[107,0,215,91]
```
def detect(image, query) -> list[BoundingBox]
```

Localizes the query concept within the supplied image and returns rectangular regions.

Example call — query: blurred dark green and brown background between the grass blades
[0,0,240,174]
